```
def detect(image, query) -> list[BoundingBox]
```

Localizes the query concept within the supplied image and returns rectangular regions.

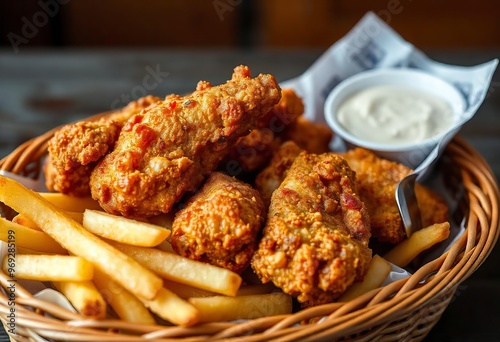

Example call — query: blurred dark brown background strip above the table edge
[0,0,500,49]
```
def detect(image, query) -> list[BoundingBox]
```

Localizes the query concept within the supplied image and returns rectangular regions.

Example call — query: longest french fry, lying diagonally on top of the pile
[0,176,163,299]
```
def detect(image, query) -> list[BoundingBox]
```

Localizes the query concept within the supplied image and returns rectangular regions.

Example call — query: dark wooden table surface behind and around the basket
[0,50,500,341]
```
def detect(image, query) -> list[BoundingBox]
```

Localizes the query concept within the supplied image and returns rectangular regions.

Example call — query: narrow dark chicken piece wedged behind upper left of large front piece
[255,141,304,207]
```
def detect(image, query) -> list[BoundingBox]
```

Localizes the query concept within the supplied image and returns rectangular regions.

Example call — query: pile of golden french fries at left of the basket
[0,176,292,326]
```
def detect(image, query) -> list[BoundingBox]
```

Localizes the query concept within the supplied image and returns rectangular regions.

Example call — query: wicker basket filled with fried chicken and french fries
[0,12,499,341]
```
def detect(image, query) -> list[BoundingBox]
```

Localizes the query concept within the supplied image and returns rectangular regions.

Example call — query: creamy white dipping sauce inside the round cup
[337,85,453,145]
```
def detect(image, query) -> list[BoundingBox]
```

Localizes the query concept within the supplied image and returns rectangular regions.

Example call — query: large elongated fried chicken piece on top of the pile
[90,66,281,217]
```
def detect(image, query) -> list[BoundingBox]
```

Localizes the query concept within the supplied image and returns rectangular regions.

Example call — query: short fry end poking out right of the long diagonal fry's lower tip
[141,288,199,326]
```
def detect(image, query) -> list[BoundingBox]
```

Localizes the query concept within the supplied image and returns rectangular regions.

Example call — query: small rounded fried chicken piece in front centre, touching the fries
[170,172,266,273]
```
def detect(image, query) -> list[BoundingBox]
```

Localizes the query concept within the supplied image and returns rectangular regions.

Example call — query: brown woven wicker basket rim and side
[0,116,499,342]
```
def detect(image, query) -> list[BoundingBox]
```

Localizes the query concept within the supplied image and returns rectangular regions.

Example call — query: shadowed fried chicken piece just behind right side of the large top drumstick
[221,88,304,173]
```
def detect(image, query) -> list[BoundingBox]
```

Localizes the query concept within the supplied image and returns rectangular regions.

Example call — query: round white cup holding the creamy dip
[324,68,466,169]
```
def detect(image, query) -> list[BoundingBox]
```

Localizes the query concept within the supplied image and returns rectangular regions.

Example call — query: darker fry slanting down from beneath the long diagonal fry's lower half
[94,270,156,324]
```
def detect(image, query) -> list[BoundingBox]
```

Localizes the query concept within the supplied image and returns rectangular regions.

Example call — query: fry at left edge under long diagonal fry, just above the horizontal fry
[0,217,68,254]
